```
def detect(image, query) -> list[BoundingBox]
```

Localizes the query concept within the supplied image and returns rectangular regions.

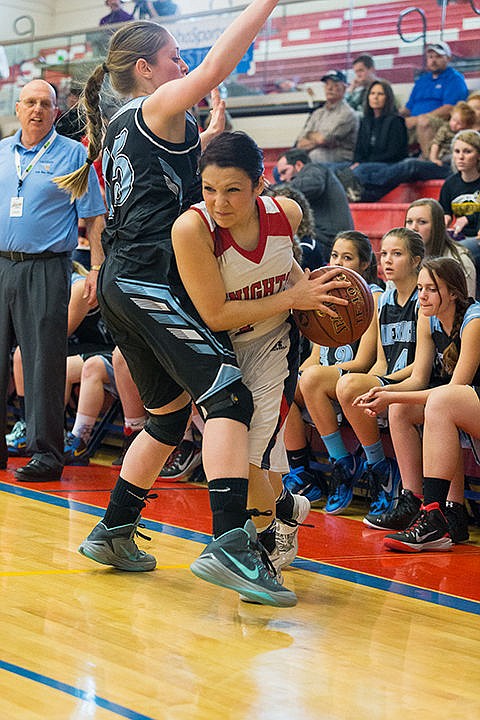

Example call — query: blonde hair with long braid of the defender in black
[54,20,171,200]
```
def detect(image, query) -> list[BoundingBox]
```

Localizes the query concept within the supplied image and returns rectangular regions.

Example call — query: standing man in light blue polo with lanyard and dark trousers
[0,80,105,482]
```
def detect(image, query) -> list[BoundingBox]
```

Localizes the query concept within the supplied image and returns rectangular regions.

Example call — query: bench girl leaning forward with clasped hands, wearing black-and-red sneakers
[354,258,480,552]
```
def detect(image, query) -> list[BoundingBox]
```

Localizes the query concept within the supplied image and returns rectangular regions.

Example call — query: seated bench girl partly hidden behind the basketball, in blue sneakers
[283,230,382,503]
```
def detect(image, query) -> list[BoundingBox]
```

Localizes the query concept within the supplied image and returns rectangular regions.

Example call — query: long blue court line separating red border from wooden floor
[0,482,480,615]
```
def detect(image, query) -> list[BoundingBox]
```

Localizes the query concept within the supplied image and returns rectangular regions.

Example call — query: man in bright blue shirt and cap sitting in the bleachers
[399,41,468,160]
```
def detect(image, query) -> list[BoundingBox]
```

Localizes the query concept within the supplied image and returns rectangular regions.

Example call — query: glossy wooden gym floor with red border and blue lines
[0,460,480,720]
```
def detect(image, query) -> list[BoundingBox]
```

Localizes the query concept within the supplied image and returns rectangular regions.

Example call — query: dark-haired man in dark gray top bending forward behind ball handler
[276,148,353,260]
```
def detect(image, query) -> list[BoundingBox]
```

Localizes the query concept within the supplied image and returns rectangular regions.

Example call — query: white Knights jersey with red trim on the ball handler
[191,196,293,345]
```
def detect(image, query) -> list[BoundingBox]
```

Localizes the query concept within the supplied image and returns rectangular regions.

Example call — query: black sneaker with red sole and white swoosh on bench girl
[383,503,453,552]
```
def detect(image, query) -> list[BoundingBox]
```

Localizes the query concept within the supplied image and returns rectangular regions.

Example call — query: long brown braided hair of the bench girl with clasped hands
[420,258,474,376]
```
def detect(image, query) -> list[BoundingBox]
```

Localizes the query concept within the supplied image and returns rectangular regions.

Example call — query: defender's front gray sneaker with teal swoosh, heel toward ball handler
[190,520,297,607]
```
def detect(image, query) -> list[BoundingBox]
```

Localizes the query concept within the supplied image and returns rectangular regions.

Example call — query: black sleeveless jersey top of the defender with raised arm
[102,98,200,247]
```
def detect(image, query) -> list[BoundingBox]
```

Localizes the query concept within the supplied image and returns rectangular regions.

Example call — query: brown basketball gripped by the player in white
[293,265,374,347]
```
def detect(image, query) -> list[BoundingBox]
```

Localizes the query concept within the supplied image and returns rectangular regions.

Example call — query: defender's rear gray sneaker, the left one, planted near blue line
[78,515,157,572]
